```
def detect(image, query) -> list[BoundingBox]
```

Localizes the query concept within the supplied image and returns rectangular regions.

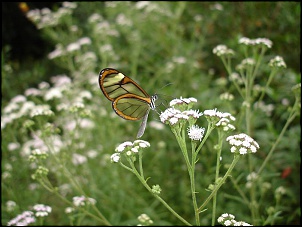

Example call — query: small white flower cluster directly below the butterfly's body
[110,140,150,162]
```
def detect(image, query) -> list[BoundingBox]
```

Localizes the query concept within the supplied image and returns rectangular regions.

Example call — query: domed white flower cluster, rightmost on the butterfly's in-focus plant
[226,133,260,155]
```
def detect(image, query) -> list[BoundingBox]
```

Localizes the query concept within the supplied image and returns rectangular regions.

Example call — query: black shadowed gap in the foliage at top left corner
[2,2,60,61]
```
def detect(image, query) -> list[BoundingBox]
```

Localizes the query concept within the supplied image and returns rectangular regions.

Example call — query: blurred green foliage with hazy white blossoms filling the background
[1,1,301,225]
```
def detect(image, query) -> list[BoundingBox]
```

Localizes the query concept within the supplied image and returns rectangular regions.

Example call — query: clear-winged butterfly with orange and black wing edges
[99,68,158,138]
